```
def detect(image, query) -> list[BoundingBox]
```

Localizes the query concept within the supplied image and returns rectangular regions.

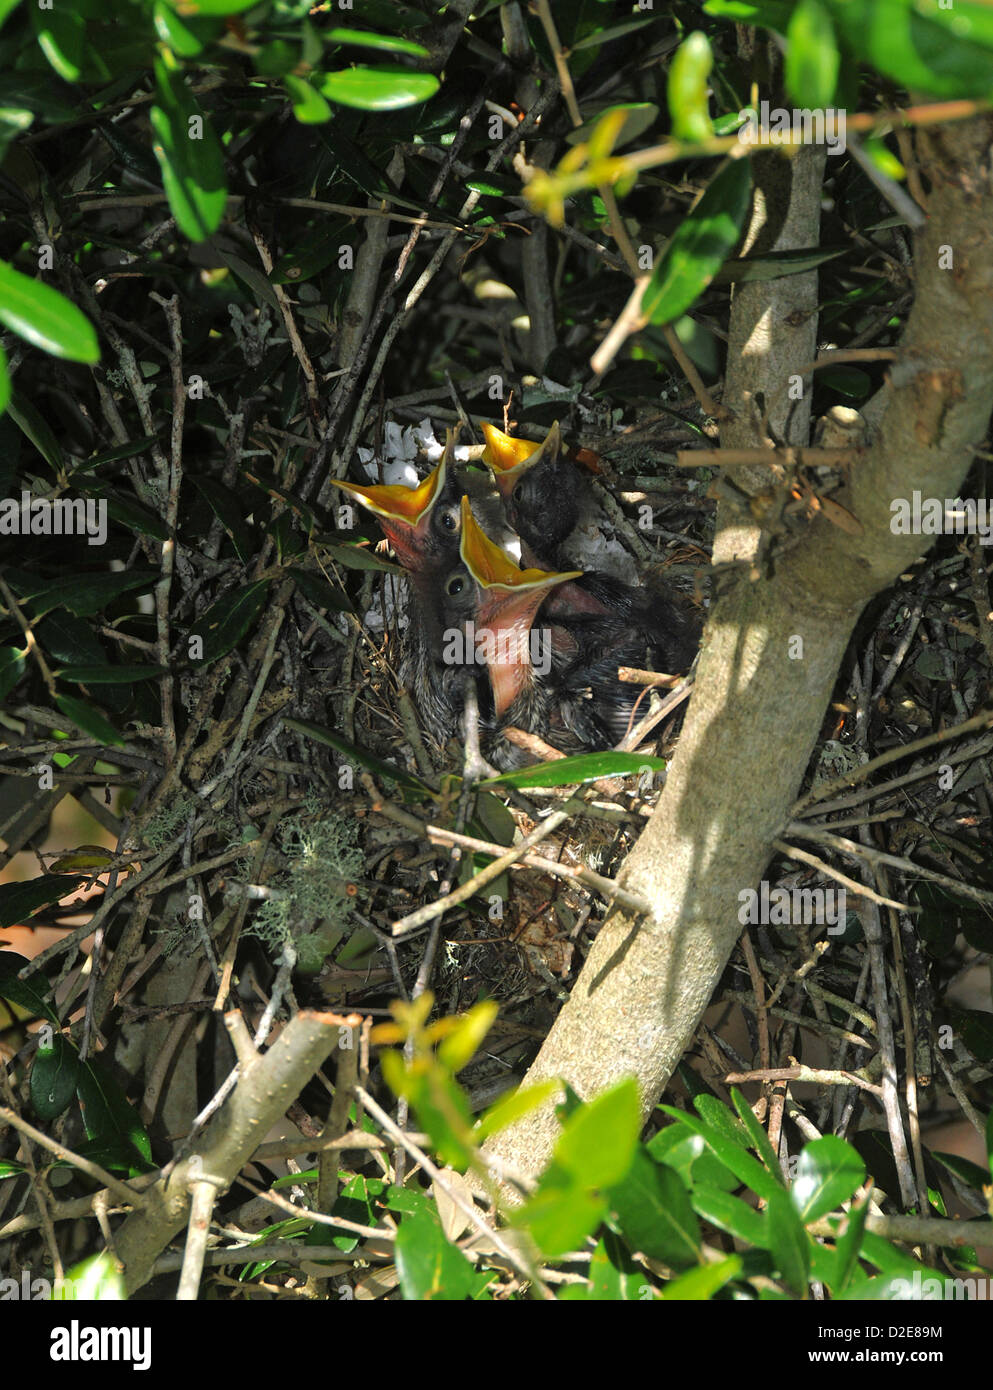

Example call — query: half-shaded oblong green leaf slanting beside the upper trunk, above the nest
[641,160,751,324]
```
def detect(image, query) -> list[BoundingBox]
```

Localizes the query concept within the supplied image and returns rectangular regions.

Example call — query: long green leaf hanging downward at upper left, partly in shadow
[149,59,226,242]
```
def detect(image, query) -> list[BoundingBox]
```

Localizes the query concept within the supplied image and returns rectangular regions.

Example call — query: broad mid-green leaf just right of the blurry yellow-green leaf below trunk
[609,1148,701,1269]
